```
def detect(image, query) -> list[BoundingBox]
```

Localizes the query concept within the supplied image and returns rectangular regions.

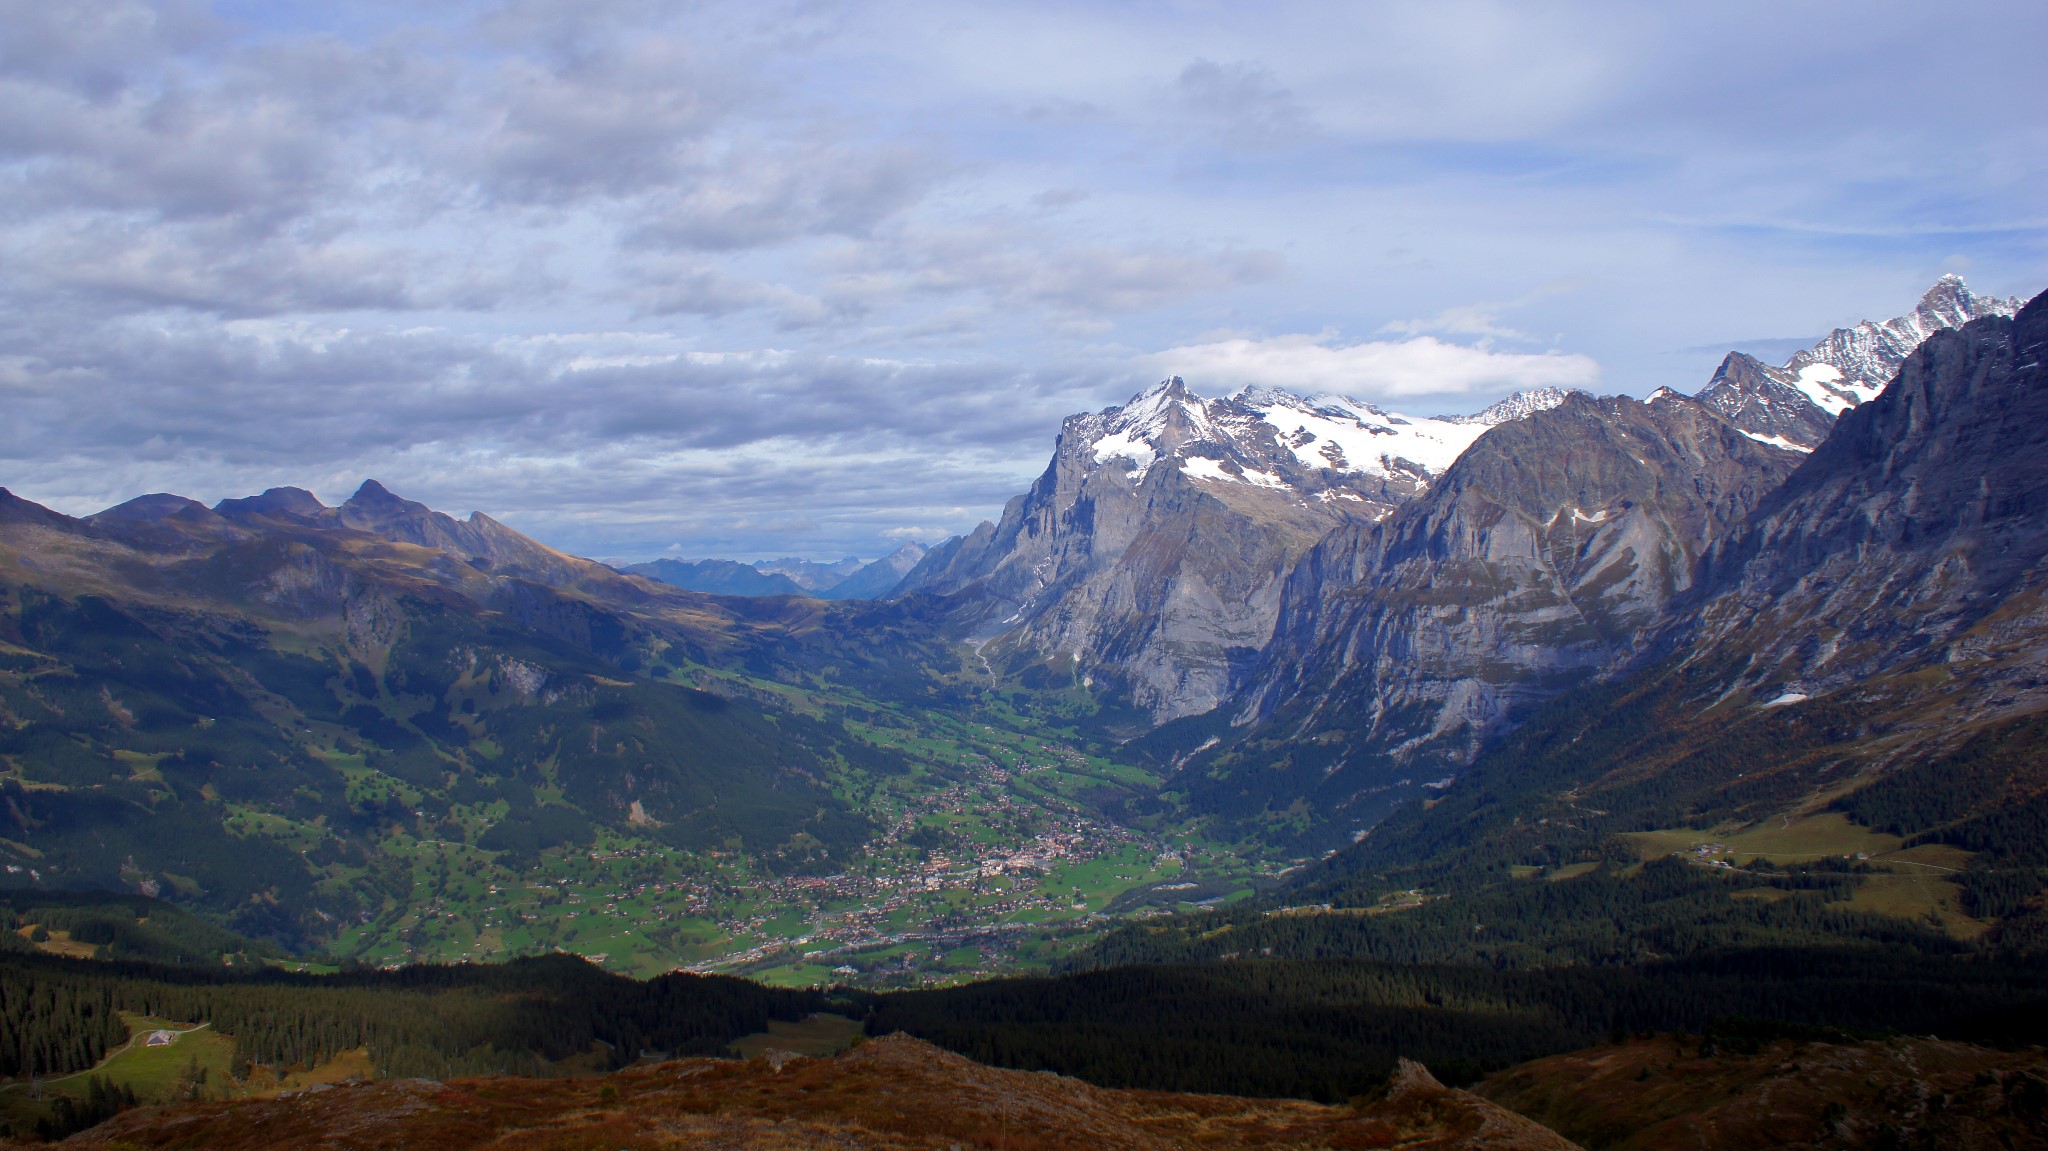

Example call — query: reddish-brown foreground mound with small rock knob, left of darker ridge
[66,1036,1577,1151]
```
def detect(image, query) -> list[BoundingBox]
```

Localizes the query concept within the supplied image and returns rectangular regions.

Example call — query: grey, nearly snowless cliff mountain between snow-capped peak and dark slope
[1204,395,1800,815]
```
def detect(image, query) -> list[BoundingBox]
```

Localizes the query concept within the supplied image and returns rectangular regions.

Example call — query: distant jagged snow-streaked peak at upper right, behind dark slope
[1698,276,2019,451]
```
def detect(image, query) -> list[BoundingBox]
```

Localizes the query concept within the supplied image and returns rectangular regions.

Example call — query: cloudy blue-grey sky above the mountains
[0,0,2048,559]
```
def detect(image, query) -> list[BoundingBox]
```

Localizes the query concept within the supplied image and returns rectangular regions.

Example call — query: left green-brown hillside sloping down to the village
[0,475,1261,973]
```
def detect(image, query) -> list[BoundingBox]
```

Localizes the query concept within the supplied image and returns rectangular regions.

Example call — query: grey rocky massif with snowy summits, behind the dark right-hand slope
[901,276,2030,829]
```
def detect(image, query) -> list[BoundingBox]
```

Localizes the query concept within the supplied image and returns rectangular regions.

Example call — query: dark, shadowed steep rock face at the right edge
[1667,282,2048,696]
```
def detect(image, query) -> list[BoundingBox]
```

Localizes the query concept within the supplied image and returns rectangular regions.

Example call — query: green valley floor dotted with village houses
[323,700,1278,987]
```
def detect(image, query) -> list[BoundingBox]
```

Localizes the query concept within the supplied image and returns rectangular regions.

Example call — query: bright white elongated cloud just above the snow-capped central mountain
[1145,336,1599,399]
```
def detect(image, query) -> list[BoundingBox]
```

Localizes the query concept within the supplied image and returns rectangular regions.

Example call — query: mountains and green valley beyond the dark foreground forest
[0,279,2048,963]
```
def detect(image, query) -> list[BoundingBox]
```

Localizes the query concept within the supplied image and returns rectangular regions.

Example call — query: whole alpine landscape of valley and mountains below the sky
[0,276,2048,1147]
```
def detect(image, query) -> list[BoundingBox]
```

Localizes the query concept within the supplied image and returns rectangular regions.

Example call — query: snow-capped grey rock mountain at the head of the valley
[899,377,1565,721]
